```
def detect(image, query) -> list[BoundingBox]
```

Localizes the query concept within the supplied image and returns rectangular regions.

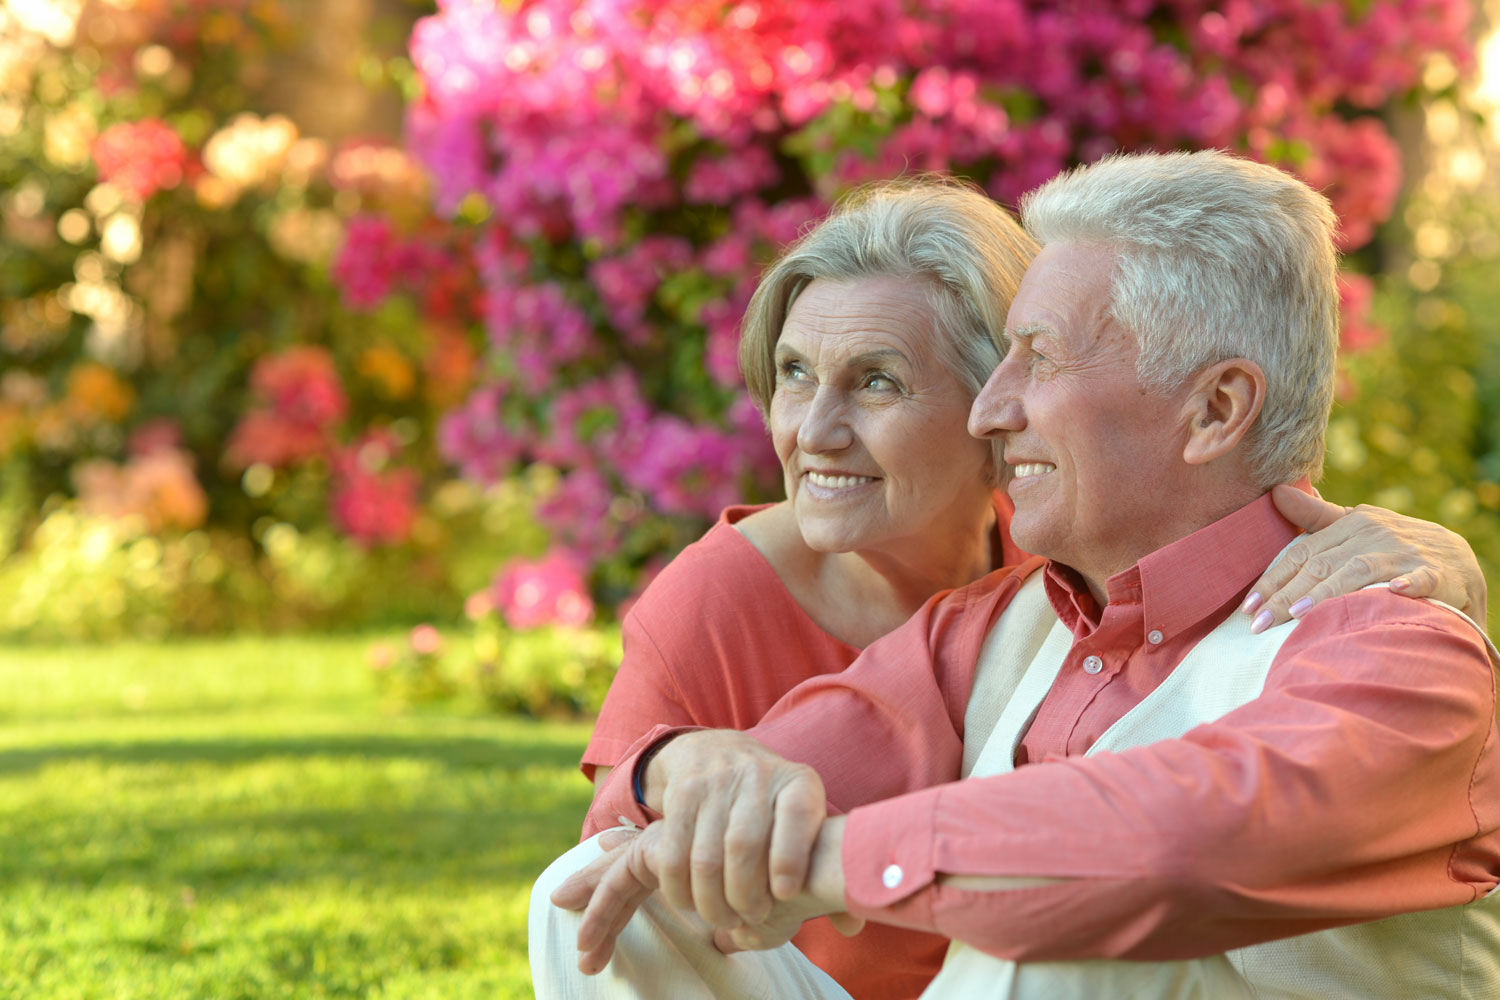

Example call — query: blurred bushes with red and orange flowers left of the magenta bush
[0,0,537,640]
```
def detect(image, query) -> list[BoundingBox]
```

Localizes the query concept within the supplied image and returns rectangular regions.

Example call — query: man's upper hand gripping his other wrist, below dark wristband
[642,730,827,928]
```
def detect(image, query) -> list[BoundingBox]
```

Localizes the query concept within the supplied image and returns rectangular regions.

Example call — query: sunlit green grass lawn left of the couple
[0,637,590,1000]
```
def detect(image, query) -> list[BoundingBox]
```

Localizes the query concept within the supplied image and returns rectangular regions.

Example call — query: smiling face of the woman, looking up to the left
[770,277,992,556]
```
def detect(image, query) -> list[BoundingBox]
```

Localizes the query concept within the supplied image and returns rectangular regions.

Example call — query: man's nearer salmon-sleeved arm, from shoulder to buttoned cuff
[843,592,1500,960]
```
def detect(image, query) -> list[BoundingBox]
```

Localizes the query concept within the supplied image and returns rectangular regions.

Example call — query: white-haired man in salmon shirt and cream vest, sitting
[533,153,1500,1000]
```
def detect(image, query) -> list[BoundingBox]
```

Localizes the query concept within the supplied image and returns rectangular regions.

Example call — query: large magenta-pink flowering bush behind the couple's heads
[372,0,1470,611]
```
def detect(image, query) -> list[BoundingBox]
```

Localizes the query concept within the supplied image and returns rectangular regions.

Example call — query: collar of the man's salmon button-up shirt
[1047,493,1299,637]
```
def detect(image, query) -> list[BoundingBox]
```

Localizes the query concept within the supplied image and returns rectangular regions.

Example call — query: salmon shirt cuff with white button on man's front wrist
[843,787,941,930]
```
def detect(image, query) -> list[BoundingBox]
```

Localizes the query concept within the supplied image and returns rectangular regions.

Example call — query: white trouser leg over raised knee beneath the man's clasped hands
[527,837,849,1000]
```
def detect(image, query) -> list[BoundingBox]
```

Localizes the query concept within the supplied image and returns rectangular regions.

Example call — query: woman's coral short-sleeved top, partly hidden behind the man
[582,492,1026,1000]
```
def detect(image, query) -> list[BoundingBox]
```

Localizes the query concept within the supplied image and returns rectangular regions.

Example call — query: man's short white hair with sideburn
[1022,150,1338,489]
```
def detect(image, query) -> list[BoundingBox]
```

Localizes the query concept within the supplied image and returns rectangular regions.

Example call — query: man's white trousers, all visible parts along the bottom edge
[528,837,1253,1000]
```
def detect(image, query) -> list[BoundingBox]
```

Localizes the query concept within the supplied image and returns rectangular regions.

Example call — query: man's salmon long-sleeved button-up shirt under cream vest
[596,498,1500,961]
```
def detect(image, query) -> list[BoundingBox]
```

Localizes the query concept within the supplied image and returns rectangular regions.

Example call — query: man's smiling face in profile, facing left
[969,243,1185,585]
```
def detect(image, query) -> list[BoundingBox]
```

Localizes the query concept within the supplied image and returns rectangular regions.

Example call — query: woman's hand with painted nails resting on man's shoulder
[1242,486,1485,633]
